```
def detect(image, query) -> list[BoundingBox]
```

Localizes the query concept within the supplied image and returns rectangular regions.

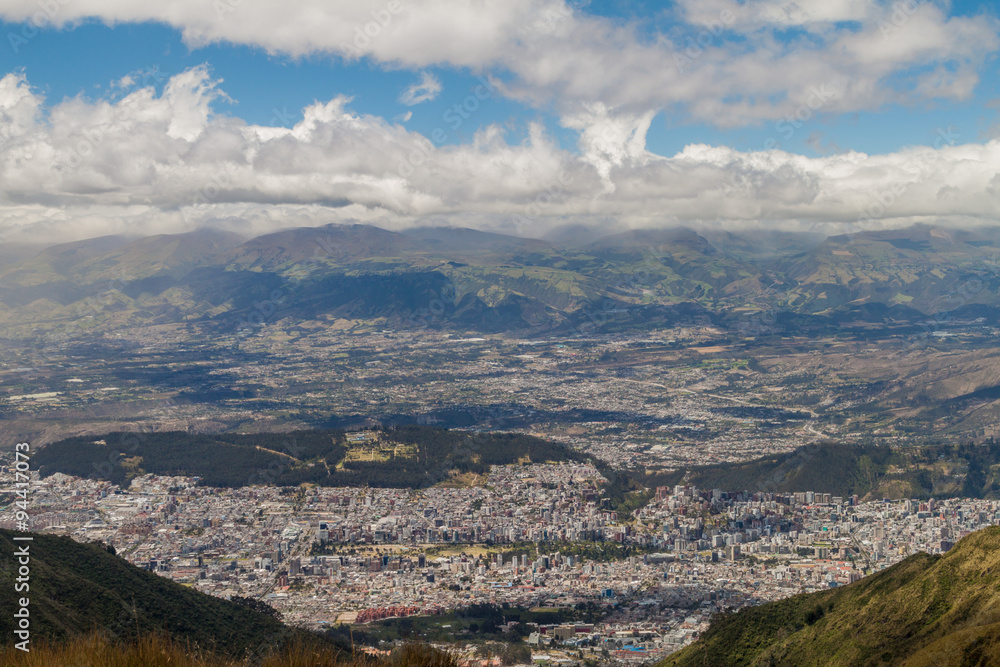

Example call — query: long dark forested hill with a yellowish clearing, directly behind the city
[34,426,586,488]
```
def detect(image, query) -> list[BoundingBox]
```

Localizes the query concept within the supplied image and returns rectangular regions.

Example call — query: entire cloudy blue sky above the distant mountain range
[0,0,1000,242]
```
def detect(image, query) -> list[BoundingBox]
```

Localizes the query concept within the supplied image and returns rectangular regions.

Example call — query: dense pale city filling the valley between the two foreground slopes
[0,456,1000,662]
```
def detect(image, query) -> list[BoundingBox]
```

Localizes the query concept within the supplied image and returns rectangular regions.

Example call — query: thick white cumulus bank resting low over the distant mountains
[0,67,1000,245]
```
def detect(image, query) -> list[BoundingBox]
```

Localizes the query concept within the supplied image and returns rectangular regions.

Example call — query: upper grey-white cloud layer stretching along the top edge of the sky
[0,0,1000,146]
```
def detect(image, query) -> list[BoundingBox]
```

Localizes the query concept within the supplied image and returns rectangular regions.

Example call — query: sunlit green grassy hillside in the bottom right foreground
[660,527,1000,667]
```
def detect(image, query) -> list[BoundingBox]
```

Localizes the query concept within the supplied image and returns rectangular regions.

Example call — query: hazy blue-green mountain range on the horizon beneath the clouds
[0,225,1000,338]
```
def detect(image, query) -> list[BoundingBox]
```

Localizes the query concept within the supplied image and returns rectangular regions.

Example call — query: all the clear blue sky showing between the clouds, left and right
[7,0,1000,155]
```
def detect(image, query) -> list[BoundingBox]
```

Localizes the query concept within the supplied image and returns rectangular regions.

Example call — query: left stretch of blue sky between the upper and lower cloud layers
[0,21,552,143]
